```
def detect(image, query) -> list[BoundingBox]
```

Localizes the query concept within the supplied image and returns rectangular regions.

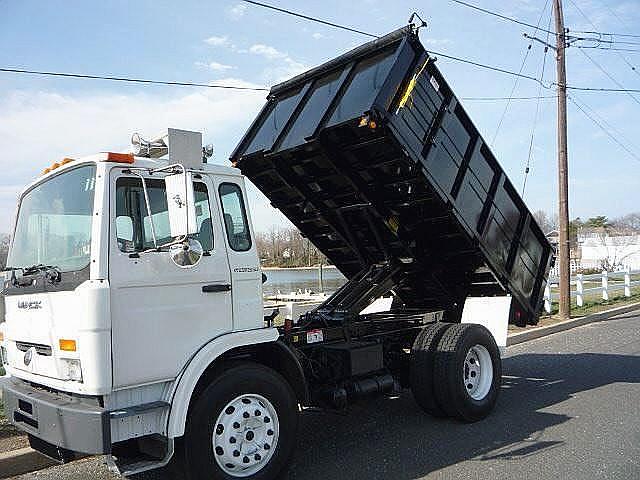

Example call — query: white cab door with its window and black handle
[109,169,233,388]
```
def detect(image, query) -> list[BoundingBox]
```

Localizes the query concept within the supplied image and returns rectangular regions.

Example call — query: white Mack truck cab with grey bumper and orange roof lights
[1,129,278,474]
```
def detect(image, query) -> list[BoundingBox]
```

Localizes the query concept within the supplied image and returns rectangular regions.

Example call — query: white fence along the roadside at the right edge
[544,268,640,313]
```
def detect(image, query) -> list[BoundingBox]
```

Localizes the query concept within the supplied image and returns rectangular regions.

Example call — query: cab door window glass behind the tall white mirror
[116,177,213,253]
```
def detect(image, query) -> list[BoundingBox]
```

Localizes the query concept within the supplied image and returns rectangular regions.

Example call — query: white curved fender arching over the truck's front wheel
[167,328,280,438]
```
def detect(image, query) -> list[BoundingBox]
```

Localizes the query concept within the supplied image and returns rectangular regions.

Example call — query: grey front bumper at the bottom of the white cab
[3,378,111,454]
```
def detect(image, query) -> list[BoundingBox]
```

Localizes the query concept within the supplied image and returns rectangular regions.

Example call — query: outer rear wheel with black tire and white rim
[434,324,502,422]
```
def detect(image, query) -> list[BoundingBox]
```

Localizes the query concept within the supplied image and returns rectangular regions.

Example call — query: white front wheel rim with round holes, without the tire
[212,393,279,477]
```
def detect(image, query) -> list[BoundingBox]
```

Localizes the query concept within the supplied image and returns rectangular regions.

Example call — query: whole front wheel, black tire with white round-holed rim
[182,362,298,480]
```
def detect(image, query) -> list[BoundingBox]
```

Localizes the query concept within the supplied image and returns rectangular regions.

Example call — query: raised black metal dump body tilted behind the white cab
[231,27,552,323]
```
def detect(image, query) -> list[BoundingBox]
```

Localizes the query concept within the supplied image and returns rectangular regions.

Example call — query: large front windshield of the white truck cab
[7,165,96,272]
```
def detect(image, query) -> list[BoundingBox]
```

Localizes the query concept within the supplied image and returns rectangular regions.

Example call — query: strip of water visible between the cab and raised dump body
[262,267,347,295]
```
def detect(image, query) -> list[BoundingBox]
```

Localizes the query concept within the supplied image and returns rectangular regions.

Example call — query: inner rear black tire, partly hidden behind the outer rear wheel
[409,322,452,417]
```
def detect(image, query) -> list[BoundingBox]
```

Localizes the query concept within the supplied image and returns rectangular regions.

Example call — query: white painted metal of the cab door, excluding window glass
[109,169,233,389]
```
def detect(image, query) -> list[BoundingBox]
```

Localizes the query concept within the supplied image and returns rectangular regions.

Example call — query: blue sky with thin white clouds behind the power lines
[0,0,640,232]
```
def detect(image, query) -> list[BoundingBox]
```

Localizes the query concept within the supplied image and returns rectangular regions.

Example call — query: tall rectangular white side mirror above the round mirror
[164,171,198,238]
